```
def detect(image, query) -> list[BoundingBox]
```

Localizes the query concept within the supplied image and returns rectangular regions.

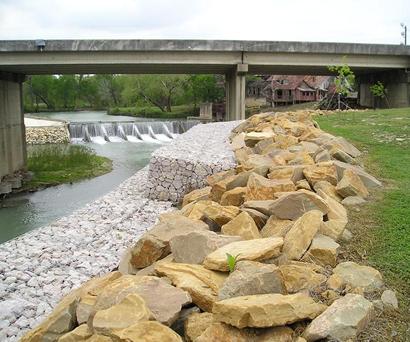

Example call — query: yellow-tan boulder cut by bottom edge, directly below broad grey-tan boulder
[112,321,182,342]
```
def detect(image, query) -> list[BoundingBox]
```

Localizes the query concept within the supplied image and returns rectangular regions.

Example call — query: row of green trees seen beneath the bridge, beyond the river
[23,75,224,112]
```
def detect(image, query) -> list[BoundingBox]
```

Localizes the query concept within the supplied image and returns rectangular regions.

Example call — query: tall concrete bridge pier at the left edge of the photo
[0,72,27,193]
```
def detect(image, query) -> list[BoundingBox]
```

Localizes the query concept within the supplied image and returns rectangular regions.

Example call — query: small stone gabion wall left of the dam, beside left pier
[26,125,70,145]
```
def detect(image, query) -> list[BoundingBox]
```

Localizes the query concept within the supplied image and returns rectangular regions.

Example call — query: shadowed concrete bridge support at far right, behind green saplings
[358,70,410,108]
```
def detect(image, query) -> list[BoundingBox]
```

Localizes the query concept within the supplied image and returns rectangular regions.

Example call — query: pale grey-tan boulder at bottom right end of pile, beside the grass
[303,294,373,342]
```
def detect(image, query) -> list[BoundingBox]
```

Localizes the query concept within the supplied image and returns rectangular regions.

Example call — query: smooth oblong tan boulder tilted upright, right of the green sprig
[283,210,323,260]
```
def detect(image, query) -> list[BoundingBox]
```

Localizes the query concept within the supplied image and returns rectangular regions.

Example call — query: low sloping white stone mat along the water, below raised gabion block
[0,169,171,341]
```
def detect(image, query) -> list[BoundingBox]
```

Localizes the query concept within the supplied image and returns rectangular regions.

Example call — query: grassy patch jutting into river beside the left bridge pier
[23,144,112,191]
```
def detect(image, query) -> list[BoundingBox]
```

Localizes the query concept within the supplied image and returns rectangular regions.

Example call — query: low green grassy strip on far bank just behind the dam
[107,105,194,119]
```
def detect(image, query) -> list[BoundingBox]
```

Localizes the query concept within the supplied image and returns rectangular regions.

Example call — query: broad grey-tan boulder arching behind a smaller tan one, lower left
[94,275,191,325]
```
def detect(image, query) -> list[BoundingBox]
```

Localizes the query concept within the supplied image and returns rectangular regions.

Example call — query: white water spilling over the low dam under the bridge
[68,120,199,144]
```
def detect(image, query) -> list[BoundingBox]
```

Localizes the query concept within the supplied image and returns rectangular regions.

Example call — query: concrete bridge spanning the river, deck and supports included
[0,40,410,190]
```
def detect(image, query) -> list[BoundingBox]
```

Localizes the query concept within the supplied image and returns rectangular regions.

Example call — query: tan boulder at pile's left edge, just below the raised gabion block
[188,201,241,226]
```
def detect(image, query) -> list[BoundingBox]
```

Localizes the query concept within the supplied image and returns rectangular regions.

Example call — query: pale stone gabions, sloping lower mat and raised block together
[0,122,238,342]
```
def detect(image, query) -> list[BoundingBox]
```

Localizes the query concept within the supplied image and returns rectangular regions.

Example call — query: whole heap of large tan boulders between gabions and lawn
[22,113,397,342]
